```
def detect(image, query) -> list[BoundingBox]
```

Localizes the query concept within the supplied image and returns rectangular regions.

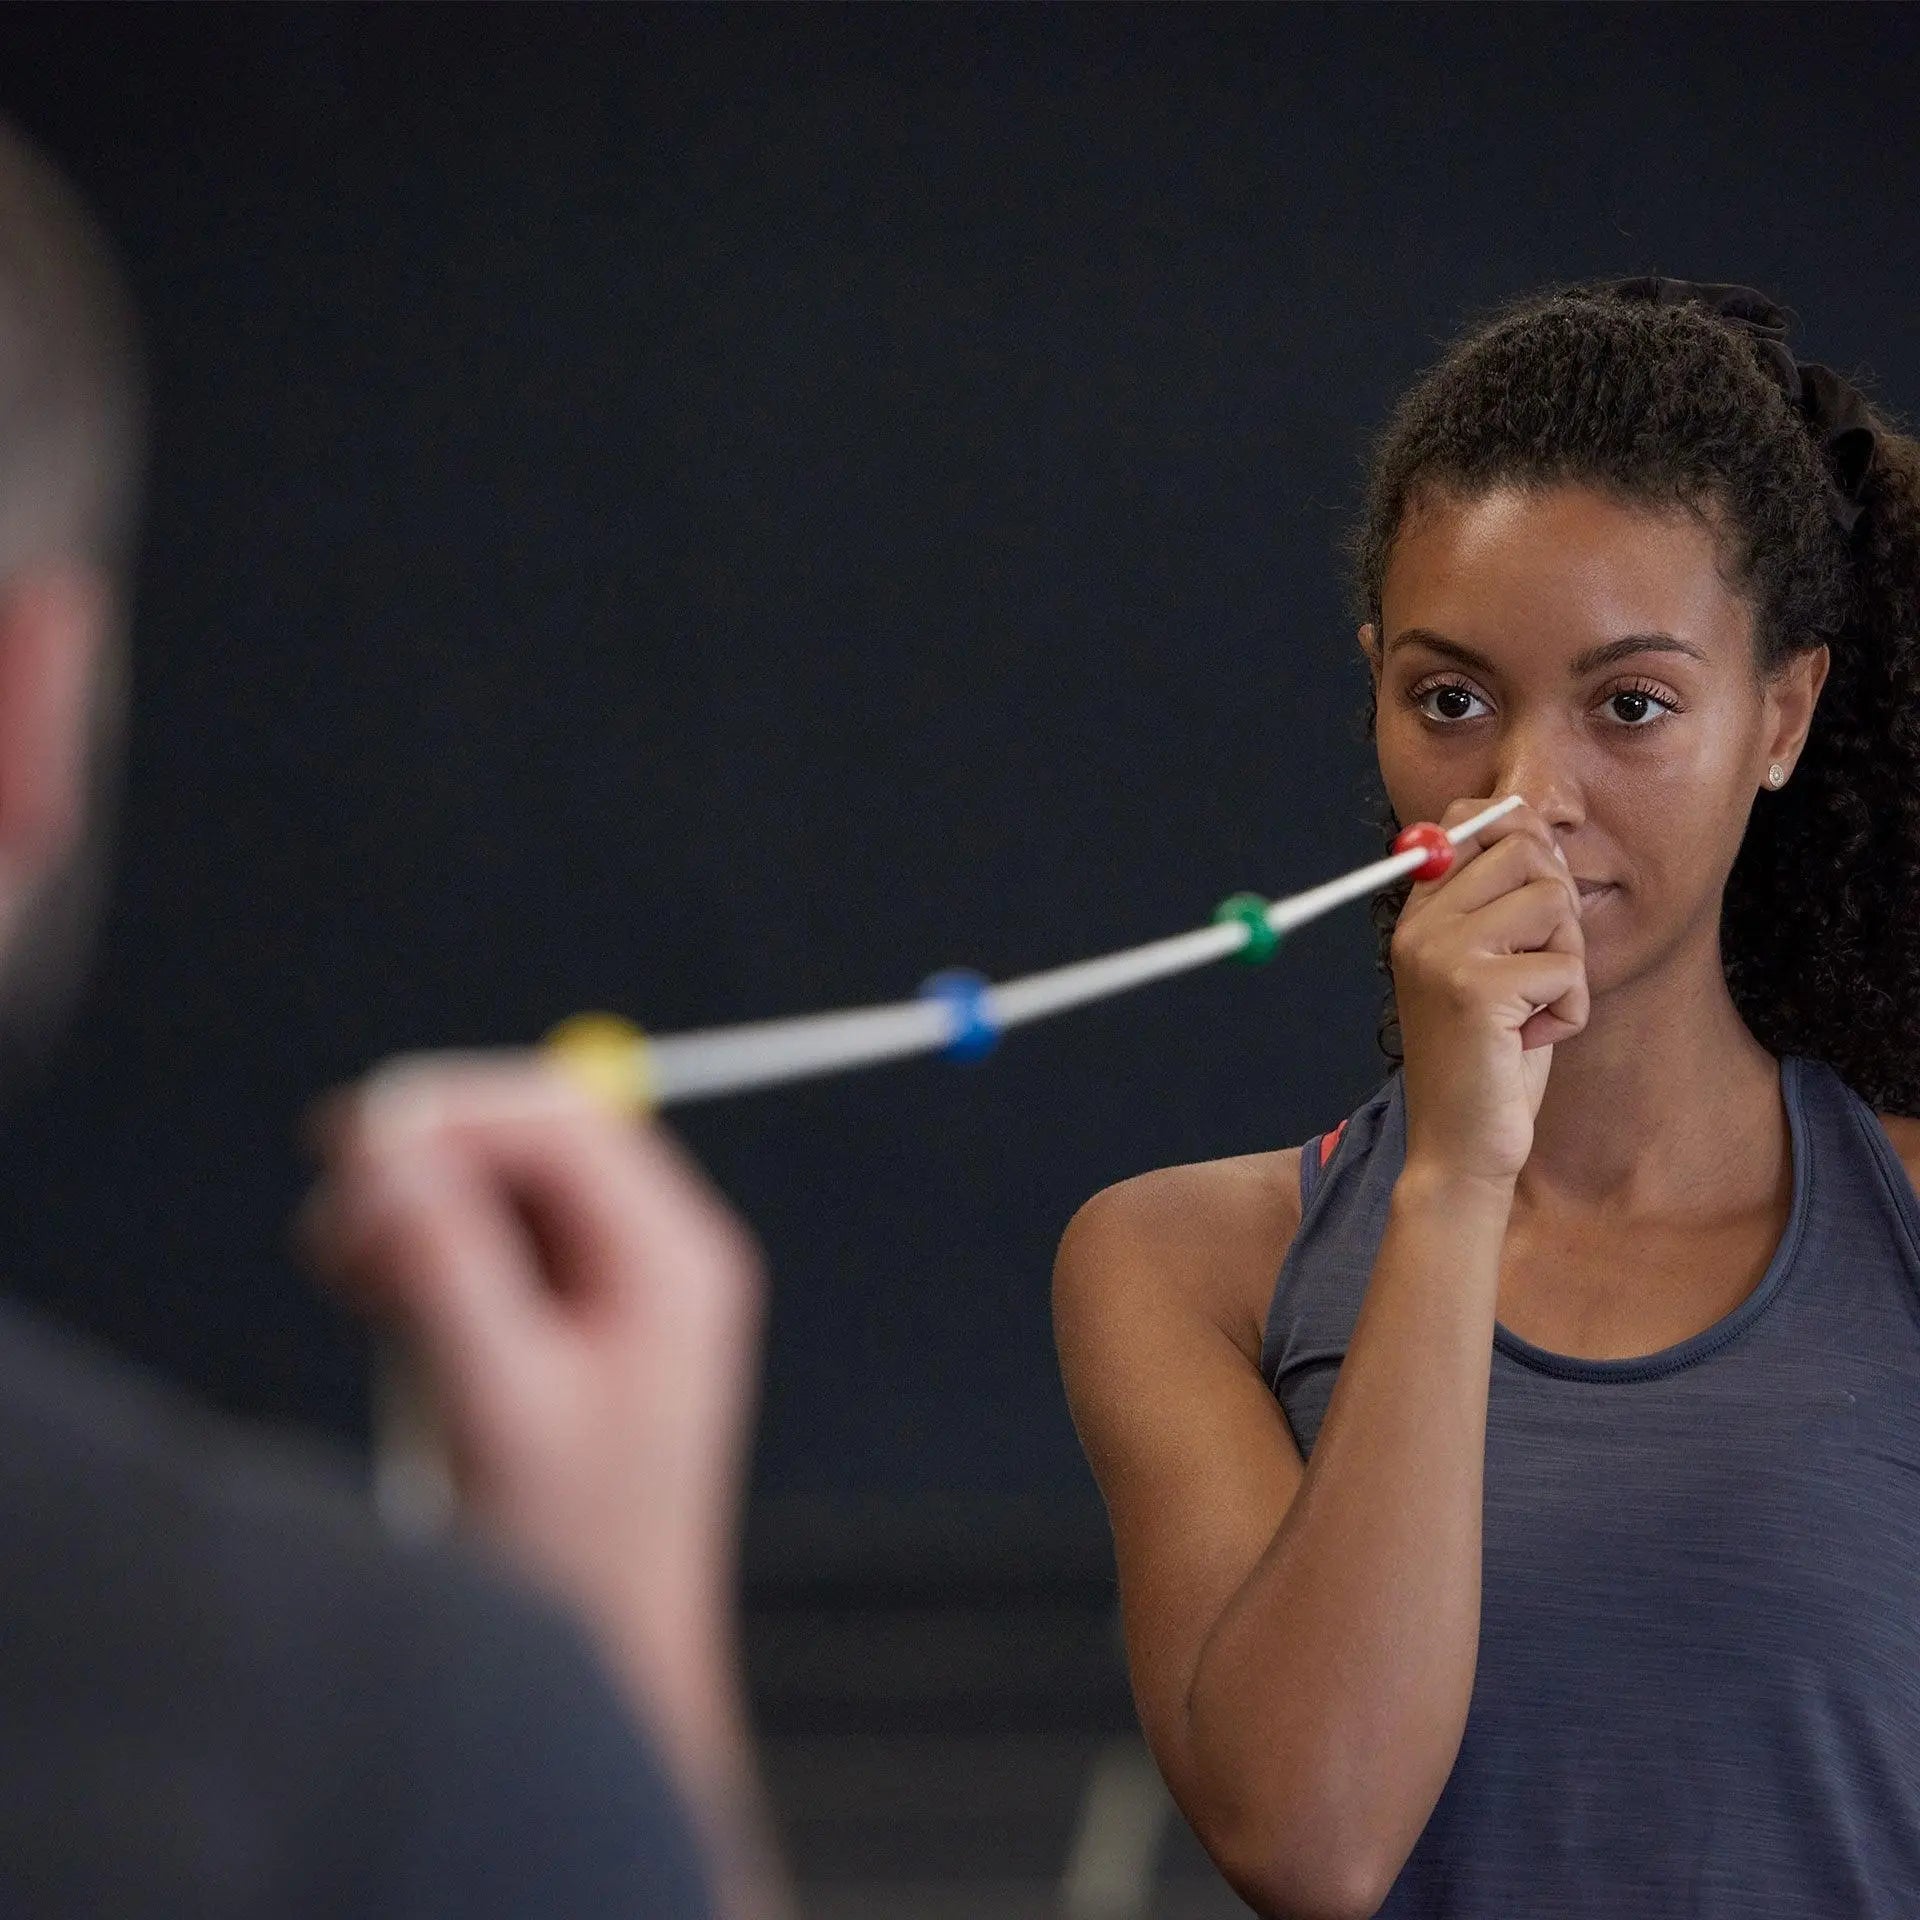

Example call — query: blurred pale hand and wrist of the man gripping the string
[298,1056,787,1910]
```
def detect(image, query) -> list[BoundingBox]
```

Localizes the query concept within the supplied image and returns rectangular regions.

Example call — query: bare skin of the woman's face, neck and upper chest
[1359,488,1873,1357]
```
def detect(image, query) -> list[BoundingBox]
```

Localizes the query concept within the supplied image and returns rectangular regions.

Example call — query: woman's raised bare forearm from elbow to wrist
[1187,1165,1513,1914]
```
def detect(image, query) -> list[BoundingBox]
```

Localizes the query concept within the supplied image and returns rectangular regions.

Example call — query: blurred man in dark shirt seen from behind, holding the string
[0,129,783,1920]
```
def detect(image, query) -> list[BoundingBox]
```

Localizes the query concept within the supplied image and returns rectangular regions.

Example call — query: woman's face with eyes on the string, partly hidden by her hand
[1361,486,1826,993]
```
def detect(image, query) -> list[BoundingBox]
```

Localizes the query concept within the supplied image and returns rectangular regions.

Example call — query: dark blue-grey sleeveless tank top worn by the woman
[1261,1054,1920,1920]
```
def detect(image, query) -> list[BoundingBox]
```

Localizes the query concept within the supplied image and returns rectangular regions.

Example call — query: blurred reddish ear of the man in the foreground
[0,564,111,887]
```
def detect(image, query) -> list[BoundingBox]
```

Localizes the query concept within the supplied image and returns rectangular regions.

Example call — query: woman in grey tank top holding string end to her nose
[1056,280,1920,1920]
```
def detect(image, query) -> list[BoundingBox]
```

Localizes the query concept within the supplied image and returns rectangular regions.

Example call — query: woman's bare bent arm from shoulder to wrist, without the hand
[1054,1154,1511,1920]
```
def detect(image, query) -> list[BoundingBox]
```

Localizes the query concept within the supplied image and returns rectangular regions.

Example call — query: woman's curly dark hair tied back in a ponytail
[1350,286,1920,1114]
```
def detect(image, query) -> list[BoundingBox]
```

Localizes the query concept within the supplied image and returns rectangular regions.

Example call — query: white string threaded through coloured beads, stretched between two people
[647,793,1523,1106]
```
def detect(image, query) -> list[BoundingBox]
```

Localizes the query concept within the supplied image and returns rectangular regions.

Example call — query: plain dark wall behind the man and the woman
[0,6,1920,1582]
